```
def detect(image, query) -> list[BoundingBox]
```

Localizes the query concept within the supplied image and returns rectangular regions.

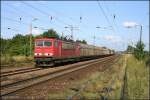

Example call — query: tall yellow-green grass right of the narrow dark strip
[127,55,149,99]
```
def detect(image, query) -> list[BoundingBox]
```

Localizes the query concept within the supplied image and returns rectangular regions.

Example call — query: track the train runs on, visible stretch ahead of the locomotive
[0,67,42,77]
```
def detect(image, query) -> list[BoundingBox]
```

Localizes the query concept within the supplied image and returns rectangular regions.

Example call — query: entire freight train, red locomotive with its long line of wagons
[34,38,114,66]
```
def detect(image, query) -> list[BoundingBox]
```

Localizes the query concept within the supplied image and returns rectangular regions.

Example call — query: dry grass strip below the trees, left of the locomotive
[0,56,33,67]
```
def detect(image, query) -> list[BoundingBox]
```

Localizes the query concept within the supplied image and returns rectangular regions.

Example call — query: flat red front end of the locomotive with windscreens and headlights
[34,38,54,66]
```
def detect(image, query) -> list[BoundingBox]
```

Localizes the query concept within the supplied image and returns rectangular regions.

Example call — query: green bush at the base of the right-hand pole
[134,41,145,60]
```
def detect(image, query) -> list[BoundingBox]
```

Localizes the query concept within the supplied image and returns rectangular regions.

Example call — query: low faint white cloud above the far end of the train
[101,35,123,43]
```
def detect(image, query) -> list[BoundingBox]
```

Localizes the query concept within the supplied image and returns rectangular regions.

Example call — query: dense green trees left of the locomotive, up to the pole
[0,34,33,56]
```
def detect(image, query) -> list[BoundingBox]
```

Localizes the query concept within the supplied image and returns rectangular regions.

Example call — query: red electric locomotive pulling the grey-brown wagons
[34,38,80,66]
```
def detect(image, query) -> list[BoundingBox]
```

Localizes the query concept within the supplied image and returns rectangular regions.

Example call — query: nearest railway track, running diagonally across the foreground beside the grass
[1,55,117,97]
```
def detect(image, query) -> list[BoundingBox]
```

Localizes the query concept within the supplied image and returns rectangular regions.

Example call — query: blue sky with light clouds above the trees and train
[1,1,149,50]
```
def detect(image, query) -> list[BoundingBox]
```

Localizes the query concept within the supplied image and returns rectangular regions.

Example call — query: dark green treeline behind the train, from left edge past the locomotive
[0,29,87,56]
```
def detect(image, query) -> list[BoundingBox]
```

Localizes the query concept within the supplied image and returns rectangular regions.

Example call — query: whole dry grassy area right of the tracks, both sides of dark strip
[49,55,149,100]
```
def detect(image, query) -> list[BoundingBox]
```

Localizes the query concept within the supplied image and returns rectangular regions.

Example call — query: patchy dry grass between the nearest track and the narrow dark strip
[49,57,125,99]
